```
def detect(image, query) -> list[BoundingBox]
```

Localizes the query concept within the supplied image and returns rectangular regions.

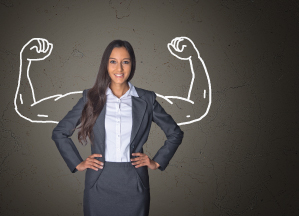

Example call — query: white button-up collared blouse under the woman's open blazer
[105,82,139,162]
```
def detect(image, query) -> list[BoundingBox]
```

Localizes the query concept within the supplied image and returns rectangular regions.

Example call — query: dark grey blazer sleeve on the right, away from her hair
[152,92,184,171]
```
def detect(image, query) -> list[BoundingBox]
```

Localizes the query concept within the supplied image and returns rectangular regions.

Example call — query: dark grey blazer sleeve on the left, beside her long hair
[52,90,86,173]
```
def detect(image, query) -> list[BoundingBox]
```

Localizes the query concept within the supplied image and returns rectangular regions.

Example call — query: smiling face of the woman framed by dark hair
[107,47,131,85]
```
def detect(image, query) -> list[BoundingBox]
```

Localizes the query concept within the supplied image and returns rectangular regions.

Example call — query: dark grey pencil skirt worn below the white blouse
[83,161,150,216]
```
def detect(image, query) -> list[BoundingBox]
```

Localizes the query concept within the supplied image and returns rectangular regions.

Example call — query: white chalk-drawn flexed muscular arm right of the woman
[157,36,212,125]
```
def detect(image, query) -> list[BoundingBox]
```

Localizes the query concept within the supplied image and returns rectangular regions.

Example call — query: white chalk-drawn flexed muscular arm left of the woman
[14,38,82,123]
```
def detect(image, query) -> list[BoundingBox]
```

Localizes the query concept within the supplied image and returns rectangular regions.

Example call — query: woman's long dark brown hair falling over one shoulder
[78,40,136,145]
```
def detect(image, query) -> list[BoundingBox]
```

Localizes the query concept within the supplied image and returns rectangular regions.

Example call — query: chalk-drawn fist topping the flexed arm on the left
[20,38,53,61]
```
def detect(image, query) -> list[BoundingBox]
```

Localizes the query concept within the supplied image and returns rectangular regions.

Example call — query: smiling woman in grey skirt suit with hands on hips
[52,40,184,216]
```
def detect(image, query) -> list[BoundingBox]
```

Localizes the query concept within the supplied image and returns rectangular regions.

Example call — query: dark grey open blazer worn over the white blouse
[52,86,184,188]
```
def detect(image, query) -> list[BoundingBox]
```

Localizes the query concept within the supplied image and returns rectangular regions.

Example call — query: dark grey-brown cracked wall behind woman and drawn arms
[0,0,299,216]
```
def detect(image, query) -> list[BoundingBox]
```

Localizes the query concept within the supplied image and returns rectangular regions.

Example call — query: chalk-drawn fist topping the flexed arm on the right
[167,37,199,60]
